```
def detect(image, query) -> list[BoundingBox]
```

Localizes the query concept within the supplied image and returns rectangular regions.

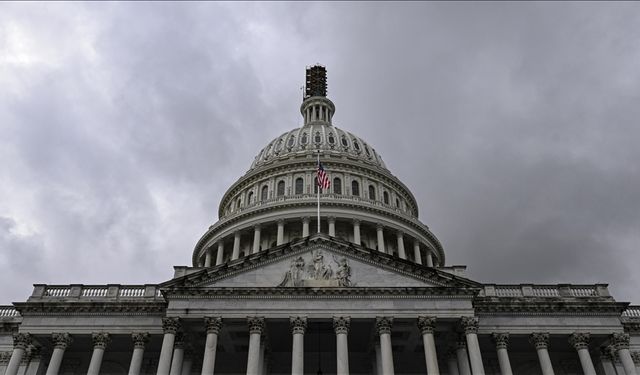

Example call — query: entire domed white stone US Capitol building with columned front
[0,66,640,375]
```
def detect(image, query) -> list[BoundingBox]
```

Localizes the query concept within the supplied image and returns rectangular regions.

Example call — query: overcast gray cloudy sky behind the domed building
[0,2,640,304]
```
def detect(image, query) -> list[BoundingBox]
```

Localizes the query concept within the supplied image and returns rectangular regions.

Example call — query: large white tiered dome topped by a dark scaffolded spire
[193,66,445,267]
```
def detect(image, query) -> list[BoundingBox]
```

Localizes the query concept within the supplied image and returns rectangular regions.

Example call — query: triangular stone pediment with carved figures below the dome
[161,234,480,288]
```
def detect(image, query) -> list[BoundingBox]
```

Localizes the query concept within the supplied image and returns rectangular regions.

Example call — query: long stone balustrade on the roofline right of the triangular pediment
[480,284,608,300]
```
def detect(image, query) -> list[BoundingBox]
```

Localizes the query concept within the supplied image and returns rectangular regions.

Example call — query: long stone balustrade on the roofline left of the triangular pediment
[29,284,163,300]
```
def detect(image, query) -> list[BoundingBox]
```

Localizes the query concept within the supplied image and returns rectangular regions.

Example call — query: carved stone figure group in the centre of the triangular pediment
[278,250,354,287]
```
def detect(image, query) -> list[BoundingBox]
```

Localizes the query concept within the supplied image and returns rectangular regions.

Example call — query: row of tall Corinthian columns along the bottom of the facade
[5,316,639,375]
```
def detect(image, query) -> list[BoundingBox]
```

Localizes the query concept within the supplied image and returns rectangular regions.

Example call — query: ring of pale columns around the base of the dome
[200,216,438,267]
